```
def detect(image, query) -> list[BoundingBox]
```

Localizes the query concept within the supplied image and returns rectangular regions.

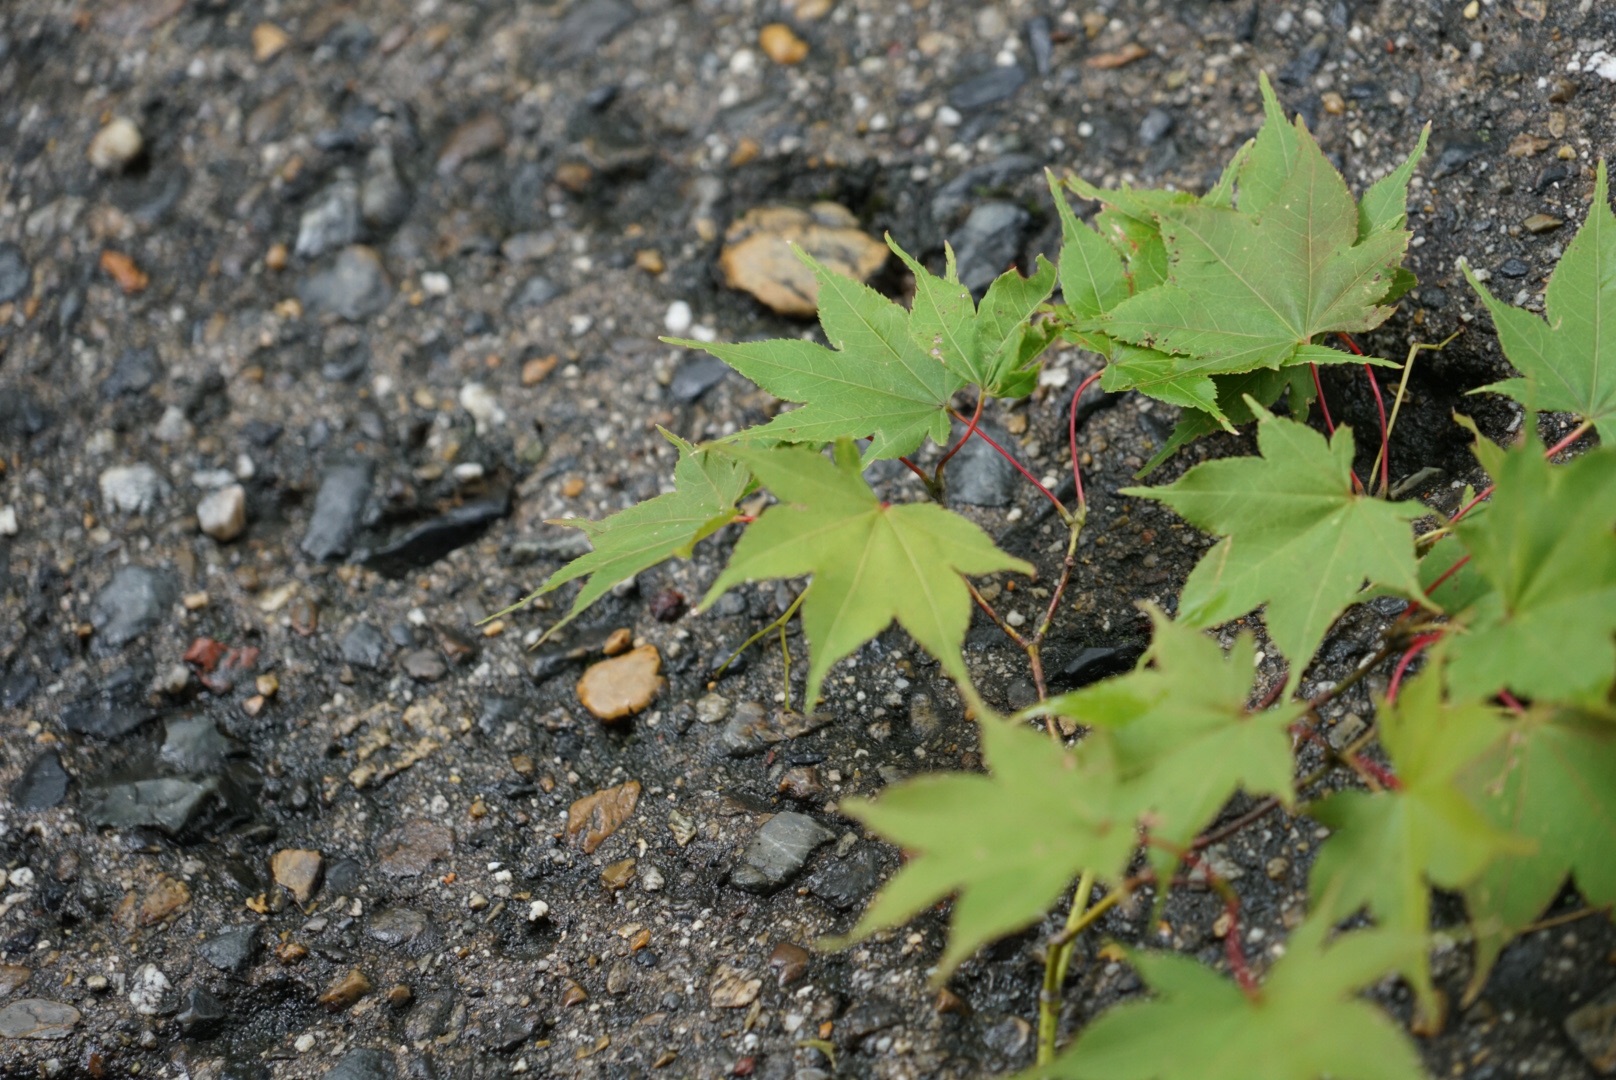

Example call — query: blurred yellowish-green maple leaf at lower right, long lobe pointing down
[1307,673,1524,1019]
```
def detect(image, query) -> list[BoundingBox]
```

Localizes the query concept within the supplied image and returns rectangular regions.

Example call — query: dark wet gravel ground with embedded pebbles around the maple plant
[0,0,1616,1080]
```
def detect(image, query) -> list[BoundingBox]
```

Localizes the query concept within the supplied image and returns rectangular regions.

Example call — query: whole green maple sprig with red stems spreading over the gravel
[504,78,1616,1080]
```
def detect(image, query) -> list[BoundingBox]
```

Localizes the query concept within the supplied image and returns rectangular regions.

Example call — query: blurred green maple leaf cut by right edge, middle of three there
[1432,424,1616,700]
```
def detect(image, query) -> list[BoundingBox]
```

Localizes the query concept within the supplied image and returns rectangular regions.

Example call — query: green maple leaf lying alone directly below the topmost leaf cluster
[1123,403,1429,686]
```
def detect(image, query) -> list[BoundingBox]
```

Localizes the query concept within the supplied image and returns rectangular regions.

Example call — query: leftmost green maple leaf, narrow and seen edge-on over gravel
[499,432,751,637]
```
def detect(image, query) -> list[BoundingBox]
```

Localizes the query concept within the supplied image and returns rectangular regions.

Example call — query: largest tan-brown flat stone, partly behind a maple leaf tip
[719,202,889,319]
